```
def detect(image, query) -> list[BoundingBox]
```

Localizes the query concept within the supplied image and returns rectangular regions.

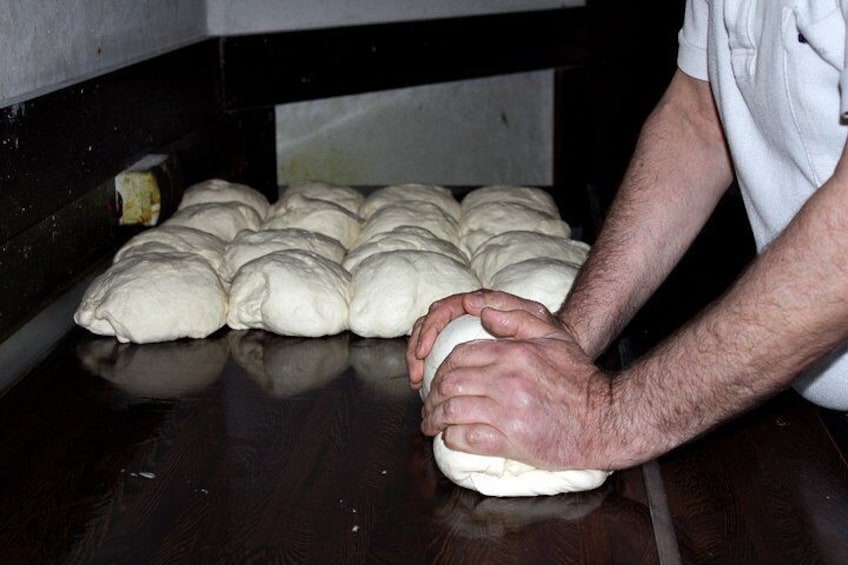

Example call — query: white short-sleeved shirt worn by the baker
[677,0,848,410]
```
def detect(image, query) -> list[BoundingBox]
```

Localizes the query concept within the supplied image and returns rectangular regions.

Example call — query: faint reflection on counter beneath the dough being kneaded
[435,480,610,538]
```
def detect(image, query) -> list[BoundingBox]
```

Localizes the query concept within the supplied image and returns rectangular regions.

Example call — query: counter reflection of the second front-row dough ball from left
[228,330,349,397]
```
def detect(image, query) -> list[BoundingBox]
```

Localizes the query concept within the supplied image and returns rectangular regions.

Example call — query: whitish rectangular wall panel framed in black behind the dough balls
[276,71,553,186]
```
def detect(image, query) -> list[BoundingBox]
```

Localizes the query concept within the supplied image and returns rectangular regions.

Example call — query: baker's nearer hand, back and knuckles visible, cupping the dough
[421,304,618,469]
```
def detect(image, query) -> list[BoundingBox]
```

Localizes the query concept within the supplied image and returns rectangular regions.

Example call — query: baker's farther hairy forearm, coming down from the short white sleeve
[559,72,732,357]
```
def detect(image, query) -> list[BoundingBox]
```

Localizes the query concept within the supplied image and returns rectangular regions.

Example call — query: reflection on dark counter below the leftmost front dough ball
[77,338,228,398]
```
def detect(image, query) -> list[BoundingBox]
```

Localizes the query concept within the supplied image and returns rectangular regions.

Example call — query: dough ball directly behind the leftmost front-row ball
[112,225,226,273]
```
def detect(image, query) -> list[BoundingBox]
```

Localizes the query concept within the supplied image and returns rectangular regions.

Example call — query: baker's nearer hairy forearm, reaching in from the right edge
[613,162,848,461]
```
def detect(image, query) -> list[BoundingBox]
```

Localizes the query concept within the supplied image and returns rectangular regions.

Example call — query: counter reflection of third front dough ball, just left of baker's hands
[350,338,412,398]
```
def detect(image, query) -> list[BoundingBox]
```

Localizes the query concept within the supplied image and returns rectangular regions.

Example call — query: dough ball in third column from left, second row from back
[357,202,459,245]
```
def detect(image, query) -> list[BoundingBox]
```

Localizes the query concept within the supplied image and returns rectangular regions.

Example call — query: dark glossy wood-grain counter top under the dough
[0,331,848,564]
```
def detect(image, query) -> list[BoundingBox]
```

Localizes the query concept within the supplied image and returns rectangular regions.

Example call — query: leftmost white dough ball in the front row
[74,253,227,343]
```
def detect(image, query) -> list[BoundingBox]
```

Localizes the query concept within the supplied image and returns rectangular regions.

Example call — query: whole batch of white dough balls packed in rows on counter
[74,179,588,343]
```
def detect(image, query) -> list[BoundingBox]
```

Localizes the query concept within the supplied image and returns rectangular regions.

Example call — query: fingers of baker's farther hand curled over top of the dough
[406,290,555,390]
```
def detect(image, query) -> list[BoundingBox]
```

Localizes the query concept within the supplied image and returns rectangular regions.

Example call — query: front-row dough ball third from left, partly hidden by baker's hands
[350,251,480,337]
